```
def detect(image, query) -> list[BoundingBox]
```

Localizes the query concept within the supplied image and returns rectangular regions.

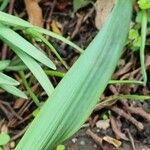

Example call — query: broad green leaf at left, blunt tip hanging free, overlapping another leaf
[0,24,56,69]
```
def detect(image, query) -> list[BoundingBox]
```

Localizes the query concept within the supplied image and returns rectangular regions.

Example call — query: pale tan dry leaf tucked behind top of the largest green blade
[95,0,115,29]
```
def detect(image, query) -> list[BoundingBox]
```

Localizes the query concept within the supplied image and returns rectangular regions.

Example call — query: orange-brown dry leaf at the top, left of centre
[24,0,43,27]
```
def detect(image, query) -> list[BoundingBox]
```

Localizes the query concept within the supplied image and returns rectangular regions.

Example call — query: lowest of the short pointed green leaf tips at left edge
[0,84,27,99]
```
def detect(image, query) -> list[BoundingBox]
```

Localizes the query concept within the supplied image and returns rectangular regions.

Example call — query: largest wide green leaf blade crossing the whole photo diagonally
[15,0,133,150]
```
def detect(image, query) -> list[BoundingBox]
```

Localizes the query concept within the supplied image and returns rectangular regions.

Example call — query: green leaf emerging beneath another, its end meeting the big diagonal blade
[13,48,54,96]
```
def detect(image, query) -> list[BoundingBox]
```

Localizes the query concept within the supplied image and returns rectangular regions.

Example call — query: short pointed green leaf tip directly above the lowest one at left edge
[0,72,19,86]
